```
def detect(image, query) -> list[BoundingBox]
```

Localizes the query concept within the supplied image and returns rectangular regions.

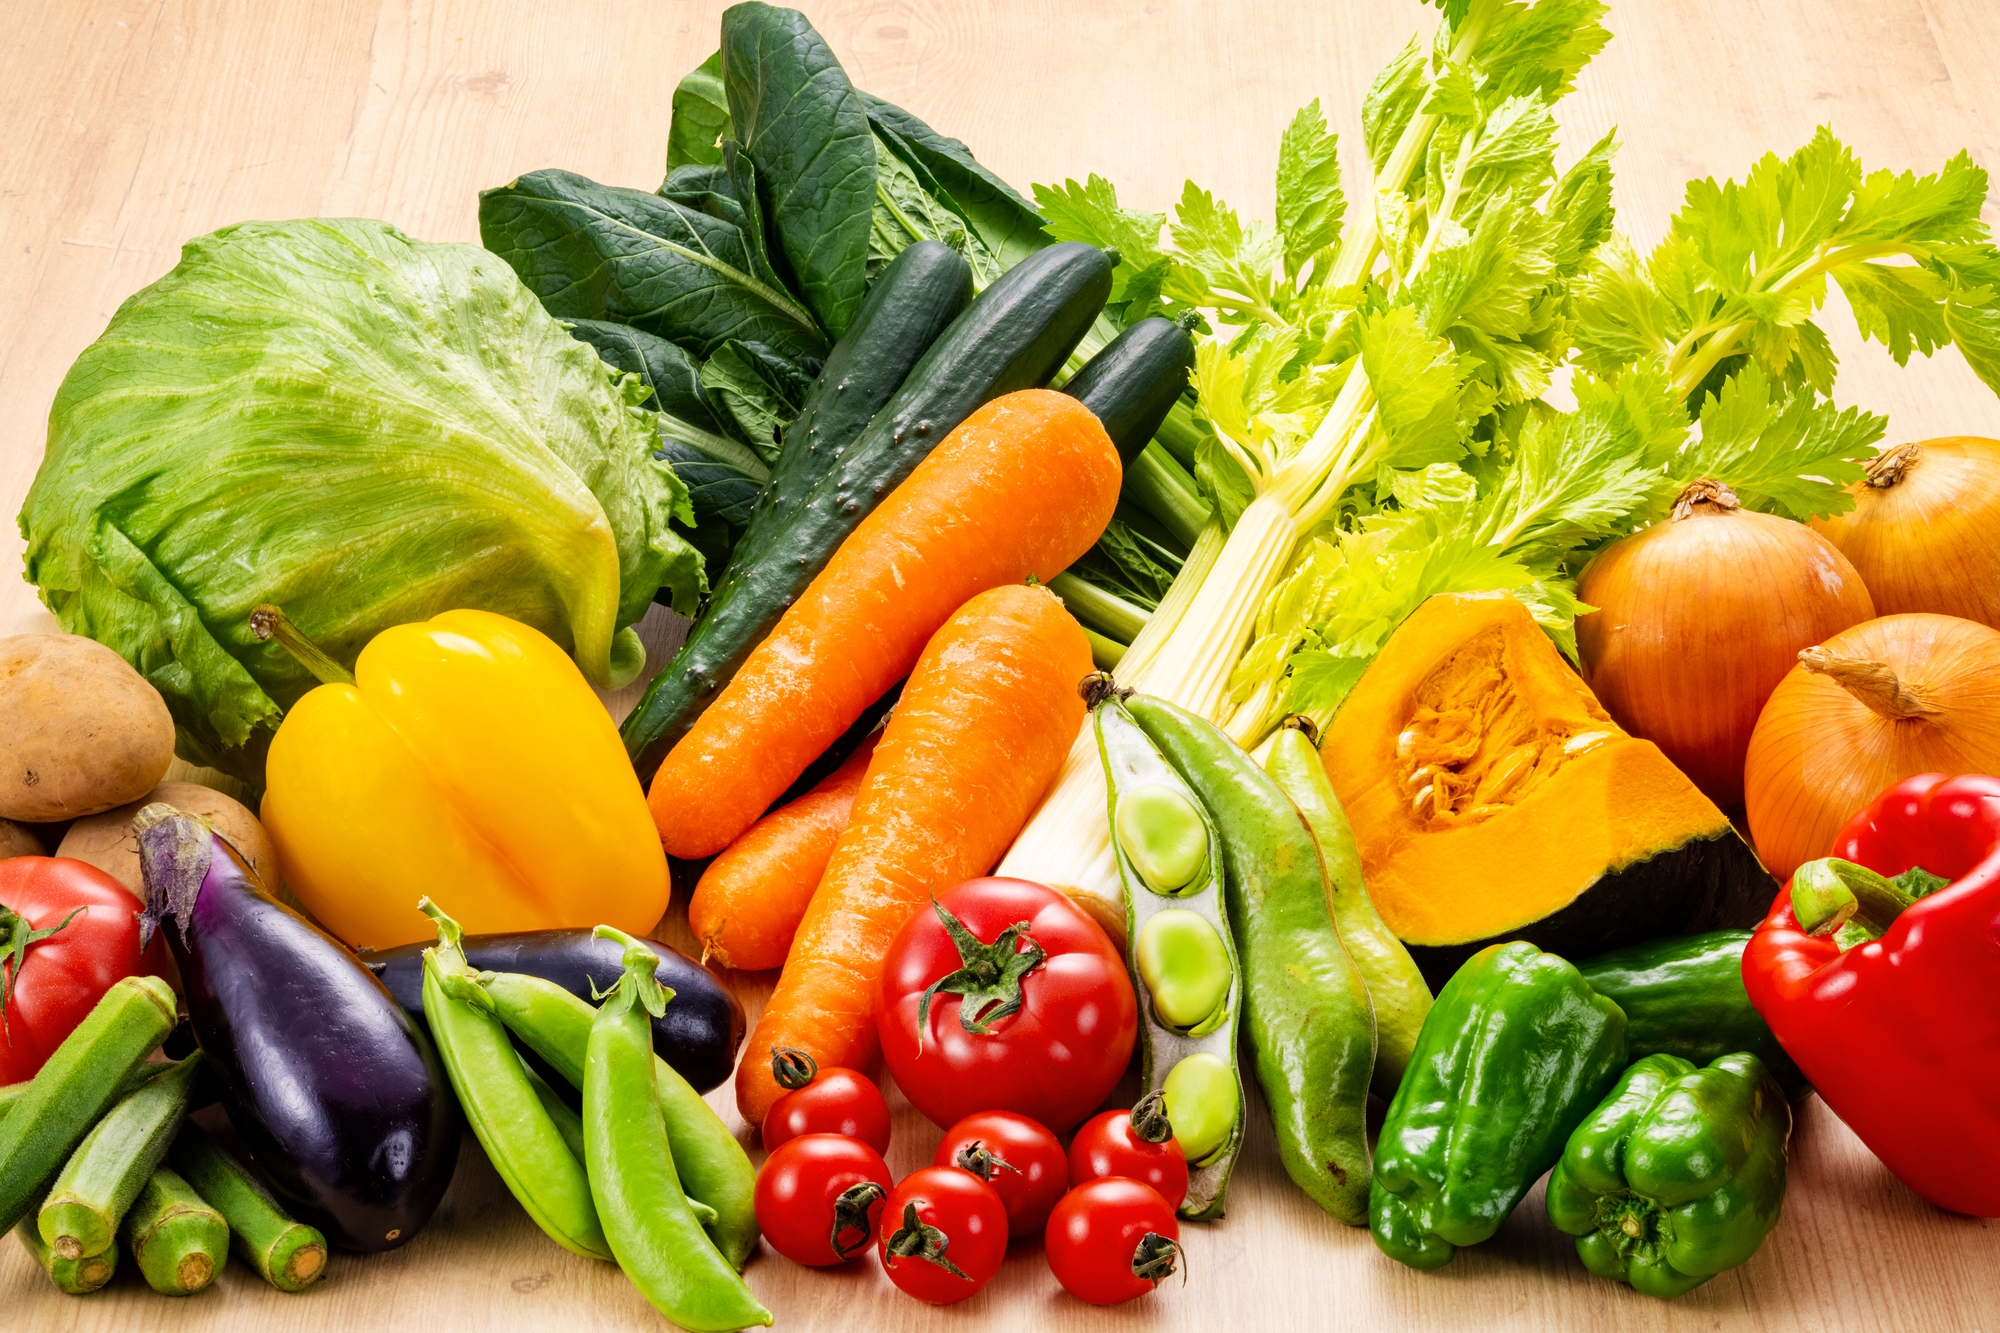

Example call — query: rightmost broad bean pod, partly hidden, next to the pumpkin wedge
[1264,723,1430,1101]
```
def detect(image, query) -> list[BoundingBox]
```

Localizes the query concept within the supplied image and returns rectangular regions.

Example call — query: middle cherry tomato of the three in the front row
[876,1167,1006,1305]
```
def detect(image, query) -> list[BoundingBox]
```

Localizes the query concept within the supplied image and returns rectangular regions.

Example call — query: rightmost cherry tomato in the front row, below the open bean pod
[1042,1175,1180,1305]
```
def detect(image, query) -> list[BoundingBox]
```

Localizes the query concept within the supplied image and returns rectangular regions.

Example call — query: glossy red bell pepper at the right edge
[1744,773,2000,1217]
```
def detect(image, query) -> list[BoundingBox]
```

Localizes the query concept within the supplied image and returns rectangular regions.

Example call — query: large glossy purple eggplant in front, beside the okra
[132,803,464,1253]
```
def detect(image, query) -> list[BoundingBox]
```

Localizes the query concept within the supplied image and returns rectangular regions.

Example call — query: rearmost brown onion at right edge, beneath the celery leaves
[1812,434,2000,628]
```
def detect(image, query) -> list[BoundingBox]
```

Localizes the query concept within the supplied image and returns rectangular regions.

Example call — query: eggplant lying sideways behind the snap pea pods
[364,931,744,1093]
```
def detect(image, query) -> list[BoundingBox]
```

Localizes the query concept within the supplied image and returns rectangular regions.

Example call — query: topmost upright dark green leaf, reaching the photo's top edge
[722,4,876,338]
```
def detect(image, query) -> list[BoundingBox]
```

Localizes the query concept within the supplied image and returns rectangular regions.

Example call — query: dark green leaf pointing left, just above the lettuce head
[480,170,826,356]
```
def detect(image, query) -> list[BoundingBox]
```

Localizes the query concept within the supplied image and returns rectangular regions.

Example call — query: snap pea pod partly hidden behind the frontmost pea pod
[480,960,758,1269]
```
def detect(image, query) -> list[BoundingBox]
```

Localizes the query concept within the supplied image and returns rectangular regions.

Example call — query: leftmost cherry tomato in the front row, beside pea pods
[756,1135,892,1269]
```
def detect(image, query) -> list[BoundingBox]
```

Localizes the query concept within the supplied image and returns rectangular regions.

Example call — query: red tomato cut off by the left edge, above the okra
[0,857,158,1085]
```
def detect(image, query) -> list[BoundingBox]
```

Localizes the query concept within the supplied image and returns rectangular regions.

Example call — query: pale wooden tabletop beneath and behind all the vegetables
[0,0,2000,1333]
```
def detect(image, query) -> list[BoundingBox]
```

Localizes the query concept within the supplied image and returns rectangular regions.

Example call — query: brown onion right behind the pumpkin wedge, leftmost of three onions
[1576,480,1874,813]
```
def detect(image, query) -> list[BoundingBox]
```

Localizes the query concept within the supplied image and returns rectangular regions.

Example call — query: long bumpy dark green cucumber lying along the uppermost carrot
[620,242,1112,783]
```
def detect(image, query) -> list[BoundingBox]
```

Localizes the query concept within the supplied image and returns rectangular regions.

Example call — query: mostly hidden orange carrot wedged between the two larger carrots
[688,733,882,969]
